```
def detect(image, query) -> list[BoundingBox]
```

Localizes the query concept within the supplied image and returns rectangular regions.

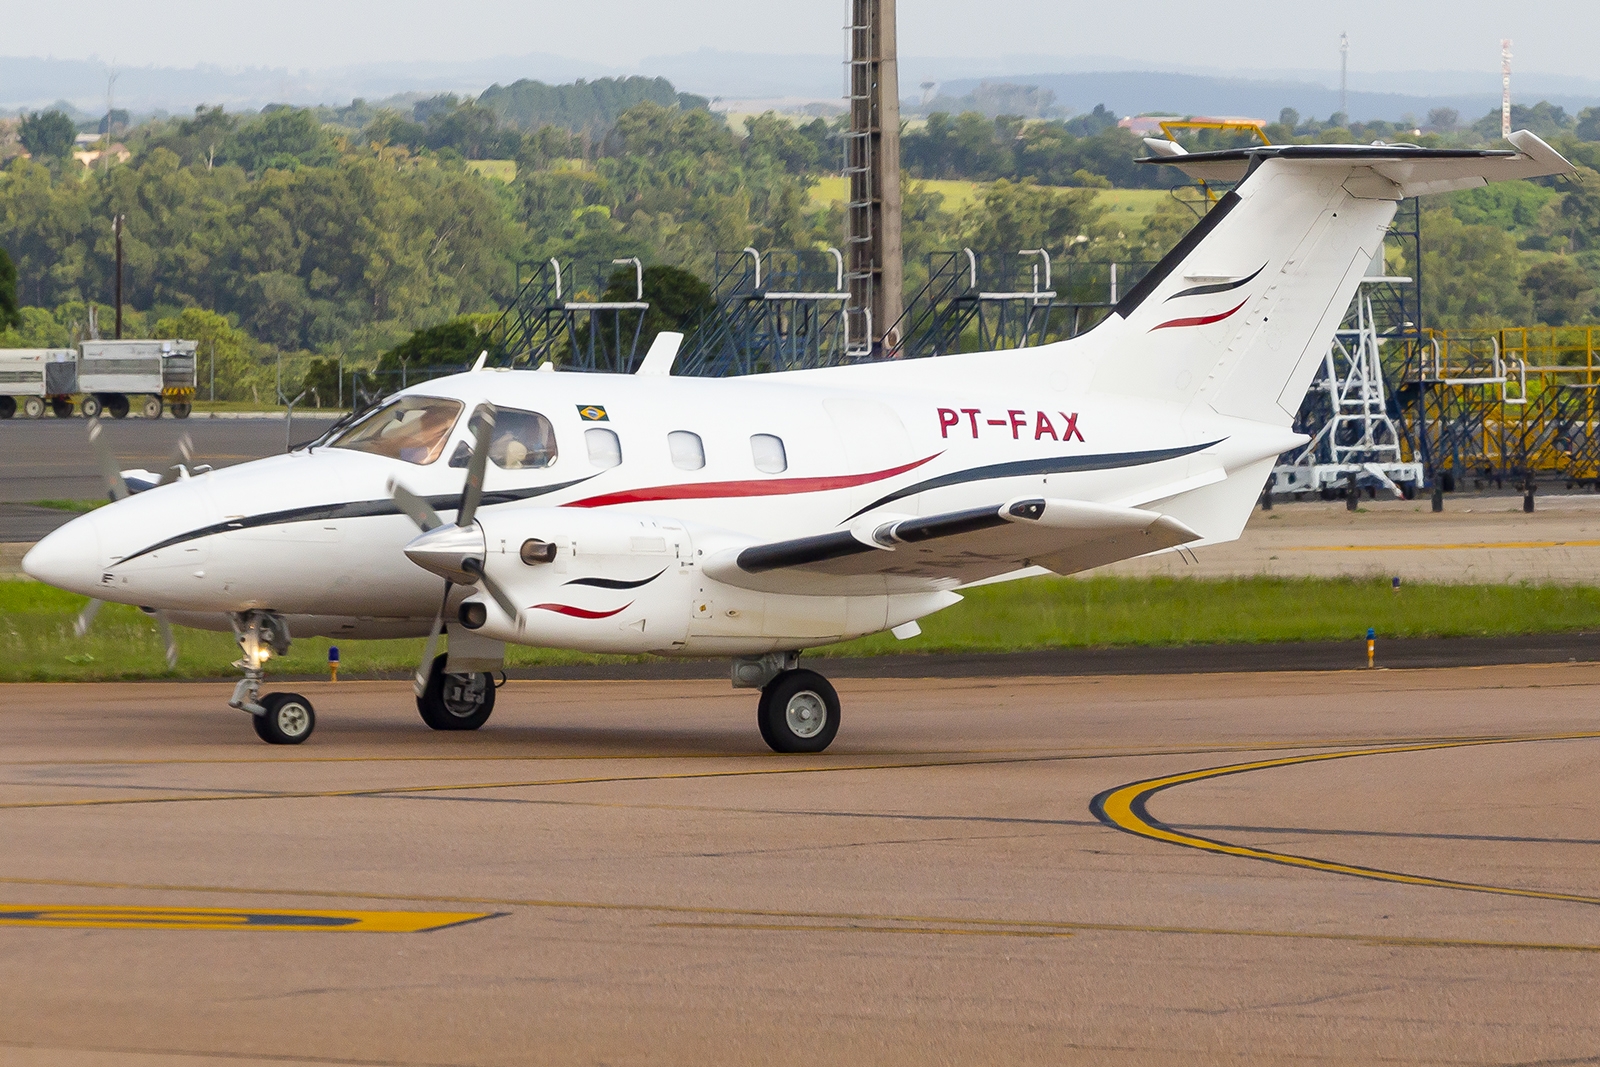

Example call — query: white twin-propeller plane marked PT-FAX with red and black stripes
[22,131,1571,752]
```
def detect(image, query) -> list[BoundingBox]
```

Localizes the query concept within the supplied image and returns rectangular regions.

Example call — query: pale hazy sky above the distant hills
[12,0,1600,77]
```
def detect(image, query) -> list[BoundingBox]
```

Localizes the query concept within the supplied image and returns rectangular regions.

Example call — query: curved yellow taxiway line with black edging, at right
[1090,731,1600,904]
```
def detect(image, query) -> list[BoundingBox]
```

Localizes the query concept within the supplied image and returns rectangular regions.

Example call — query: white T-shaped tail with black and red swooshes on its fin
[1094,131,1571,426]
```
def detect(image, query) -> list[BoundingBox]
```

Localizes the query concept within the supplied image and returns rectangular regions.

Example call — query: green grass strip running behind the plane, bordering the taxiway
[0,577,1600,681]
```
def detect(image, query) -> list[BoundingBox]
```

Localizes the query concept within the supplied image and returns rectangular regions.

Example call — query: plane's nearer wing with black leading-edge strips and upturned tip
[704,498,1200,597]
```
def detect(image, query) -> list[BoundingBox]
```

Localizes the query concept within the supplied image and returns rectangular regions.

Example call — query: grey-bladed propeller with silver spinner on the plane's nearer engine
[389,403,520,696]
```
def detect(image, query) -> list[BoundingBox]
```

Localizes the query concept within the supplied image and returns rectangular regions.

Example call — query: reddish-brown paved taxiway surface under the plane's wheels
[0,665,1600,1067]
